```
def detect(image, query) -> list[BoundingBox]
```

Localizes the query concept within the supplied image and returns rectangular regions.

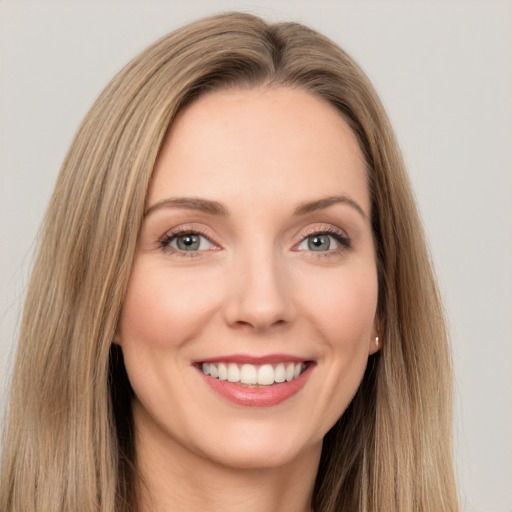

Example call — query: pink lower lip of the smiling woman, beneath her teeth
[199,365,313,407]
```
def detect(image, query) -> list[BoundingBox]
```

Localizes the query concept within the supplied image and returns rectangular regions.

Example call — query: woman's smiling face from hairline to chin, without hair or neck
[116,88,377,467]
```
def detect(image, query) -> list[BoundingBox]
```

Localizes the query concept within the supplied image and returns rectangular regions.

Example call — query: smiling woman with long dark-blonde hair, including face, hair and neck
[0,9,457,512]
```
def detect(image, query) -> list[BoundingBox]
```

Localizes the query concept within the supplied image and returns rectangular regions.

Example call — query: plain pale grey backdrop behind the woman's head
[0,0,512,512]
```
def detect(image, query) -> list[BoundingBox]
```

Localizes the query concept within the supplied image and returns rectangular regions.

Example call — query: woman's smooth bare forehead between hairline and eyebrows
[148,87,369,213]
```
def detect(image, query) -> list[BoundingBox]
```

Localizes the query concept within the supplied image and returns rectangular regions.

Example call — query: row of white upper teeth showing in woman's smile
[202,363,306,386]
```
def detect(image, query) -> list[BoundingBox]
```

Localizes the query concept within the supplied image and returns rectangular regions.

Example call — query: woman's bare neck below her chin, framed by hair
[136,410,321,512]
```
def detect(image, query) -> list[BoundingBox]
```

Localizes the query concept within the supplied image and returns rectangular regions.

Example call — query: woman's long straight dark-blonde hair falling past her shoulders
[0,13,458,512]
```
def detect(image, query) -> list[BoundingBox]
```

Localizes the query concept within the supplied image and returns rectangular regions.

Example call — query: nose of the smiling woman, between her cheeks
[224,248,294,332]
